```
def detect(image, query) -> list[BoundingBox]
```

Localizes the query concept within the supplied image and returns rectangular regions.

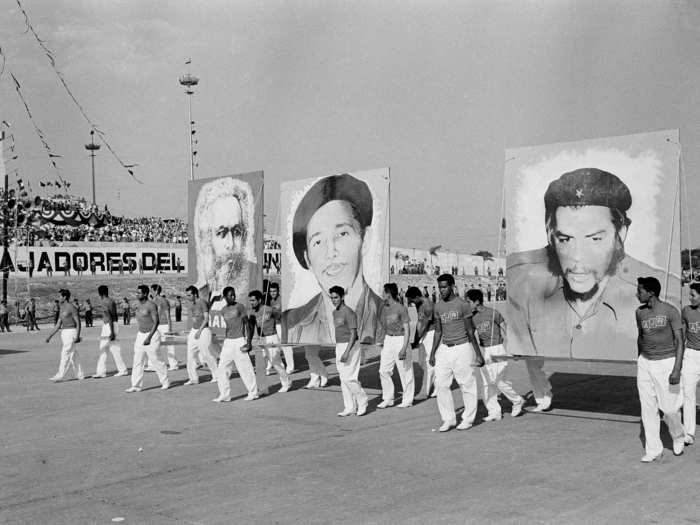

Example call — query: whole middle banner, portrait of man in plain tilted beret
[280,168,389,345]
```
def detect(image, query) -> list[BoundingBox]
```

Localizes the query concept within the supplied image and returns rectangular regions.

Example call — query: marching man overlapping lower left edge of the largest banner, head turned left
[467,289,525,421]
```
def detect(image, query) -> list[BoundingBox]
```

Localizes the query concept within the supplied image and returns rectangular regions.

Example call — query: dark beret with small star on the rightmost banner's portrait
[544,168,632,213]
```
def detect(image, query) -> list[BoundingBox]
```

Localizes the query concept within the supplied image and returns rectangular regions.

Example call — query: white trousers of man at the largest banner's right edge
[637,355,684,456]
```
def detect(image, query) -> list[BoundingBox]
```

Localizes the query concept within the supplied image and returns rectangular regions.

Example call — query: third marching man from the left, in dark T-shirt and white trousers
[126,284,170,393]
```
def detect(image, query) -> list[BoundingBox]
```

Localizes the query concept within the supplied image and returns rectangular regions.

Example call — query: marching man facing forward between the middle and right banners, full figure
[430,273,484,432]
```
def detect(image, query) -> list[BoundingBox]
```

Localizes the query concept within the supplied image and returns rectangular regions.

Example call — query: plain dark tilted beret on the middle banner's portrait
[292,173,372,270]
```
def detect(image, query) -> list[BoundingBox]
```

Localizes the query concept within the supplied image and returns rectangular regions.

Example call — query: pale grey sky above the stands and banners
[0,0,700,252]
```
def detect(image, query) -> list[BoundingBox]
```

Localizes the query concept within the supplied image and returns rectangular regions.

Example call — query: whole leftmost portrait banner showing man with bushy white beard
[187,171,264,333]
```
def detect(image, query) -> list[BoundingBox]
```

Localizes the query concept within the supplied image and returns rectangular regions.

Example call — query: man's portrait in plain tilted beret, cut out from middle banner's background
[282,173,381,344]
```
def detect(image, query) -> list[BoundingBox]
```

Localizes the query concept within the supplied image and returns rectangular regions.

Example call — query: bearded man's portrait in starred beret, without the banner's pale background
[506,167,677,359]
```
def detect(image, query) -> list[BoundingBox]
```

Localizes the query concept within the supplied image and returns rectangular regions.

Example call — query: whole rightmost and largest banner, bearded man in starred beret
[505,130,681,361]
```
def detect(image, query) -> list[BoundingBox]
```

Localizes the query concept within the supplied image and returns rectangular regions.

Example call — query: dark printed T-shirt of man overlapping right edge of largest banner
[636,301,682,360]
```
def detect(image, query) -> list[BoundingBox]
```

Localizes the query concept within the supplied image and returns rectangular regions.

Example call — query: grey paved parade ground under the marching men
[0,327,700,524]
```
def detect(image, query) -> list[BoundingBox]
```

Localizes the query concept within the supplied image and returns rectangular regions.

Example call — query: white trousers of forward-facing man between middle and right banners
[435,342,478,425]
